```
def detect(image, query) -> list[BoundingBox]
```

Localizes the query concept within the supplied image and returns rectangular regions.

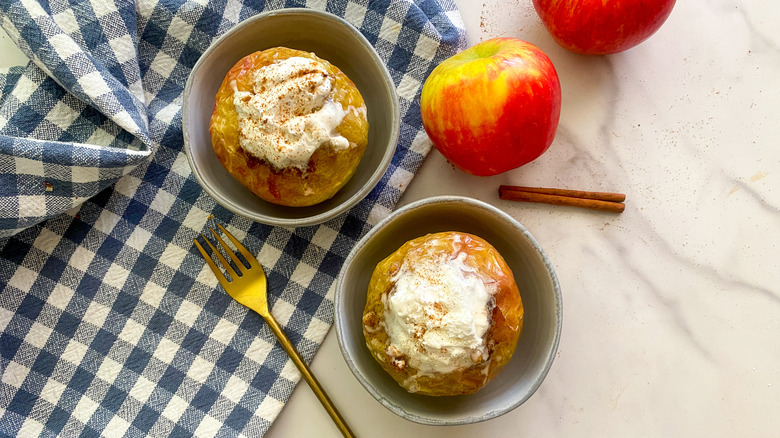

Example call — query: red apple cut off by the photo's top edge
[533,0,675,55]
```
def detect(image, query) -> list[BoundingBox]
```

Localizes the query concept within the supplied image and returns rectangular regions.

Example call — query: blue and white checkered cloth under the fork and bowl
[0,0,465,437]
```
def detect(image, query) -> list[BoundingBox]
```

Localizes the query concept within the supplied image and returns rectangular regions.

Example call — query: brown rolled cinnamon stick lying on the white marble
[498,185,626,213]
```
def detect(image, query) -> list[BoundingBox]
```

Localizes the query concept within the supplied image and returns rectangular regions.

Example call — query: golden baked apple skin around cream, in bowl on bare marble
[363,232,523,396]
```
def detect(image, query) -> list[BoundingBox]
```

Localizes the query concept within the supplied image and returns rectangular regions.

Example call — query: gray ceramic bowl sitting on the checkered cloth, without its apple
[182,9,400,228]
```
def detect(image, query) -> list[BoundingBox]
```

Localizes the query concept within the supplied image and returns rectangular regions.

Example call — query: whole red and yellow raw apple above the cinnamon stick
[420,38,561,176]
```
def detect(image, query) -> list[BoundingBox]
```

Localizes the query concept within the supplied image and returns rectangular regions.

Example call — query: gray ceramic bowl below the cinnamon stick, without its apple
[335,196,563,425]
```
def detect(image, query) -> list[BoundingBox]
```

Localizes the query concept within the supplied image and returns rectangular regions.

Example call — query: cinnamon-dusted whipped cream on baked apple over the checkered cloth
[231,57,349,170]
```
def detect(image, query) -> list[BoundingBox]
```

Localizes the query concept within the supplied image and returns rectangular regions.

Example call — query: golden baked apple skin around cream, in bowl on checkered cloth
[209,47,368,207]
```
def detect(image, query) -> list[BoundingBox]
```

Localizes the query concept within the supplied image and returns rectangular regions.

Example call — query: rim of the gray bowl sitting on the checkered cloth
[181,8,401,228]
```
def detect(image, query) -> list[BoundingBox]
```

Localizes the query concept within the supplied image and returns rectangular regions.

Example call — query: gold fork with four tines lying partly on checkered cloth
[193,224,354,437]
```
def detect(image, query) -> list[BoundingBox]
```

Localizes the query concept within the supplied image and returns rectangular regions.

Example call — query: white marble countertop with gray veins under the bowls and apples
[0,0,780,438]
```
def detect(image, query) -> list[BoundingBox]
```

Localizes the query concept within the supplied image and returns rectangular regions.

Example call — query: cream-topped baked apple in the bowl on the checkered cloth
[209,47,368,206]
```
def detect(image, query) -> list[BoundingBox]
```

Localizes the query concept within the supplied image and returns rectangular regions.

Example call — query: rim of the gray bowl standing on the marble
[334,195,563,426]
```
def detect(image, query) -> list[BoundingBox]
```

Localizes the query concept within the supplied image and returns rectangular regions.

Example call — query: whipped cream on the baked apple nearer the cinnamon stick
[383,238,497,374]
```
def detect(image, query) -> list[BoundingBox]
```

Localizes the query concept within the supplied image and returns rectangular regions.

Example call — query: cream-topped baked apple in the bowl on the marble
[363,232,523,396]
